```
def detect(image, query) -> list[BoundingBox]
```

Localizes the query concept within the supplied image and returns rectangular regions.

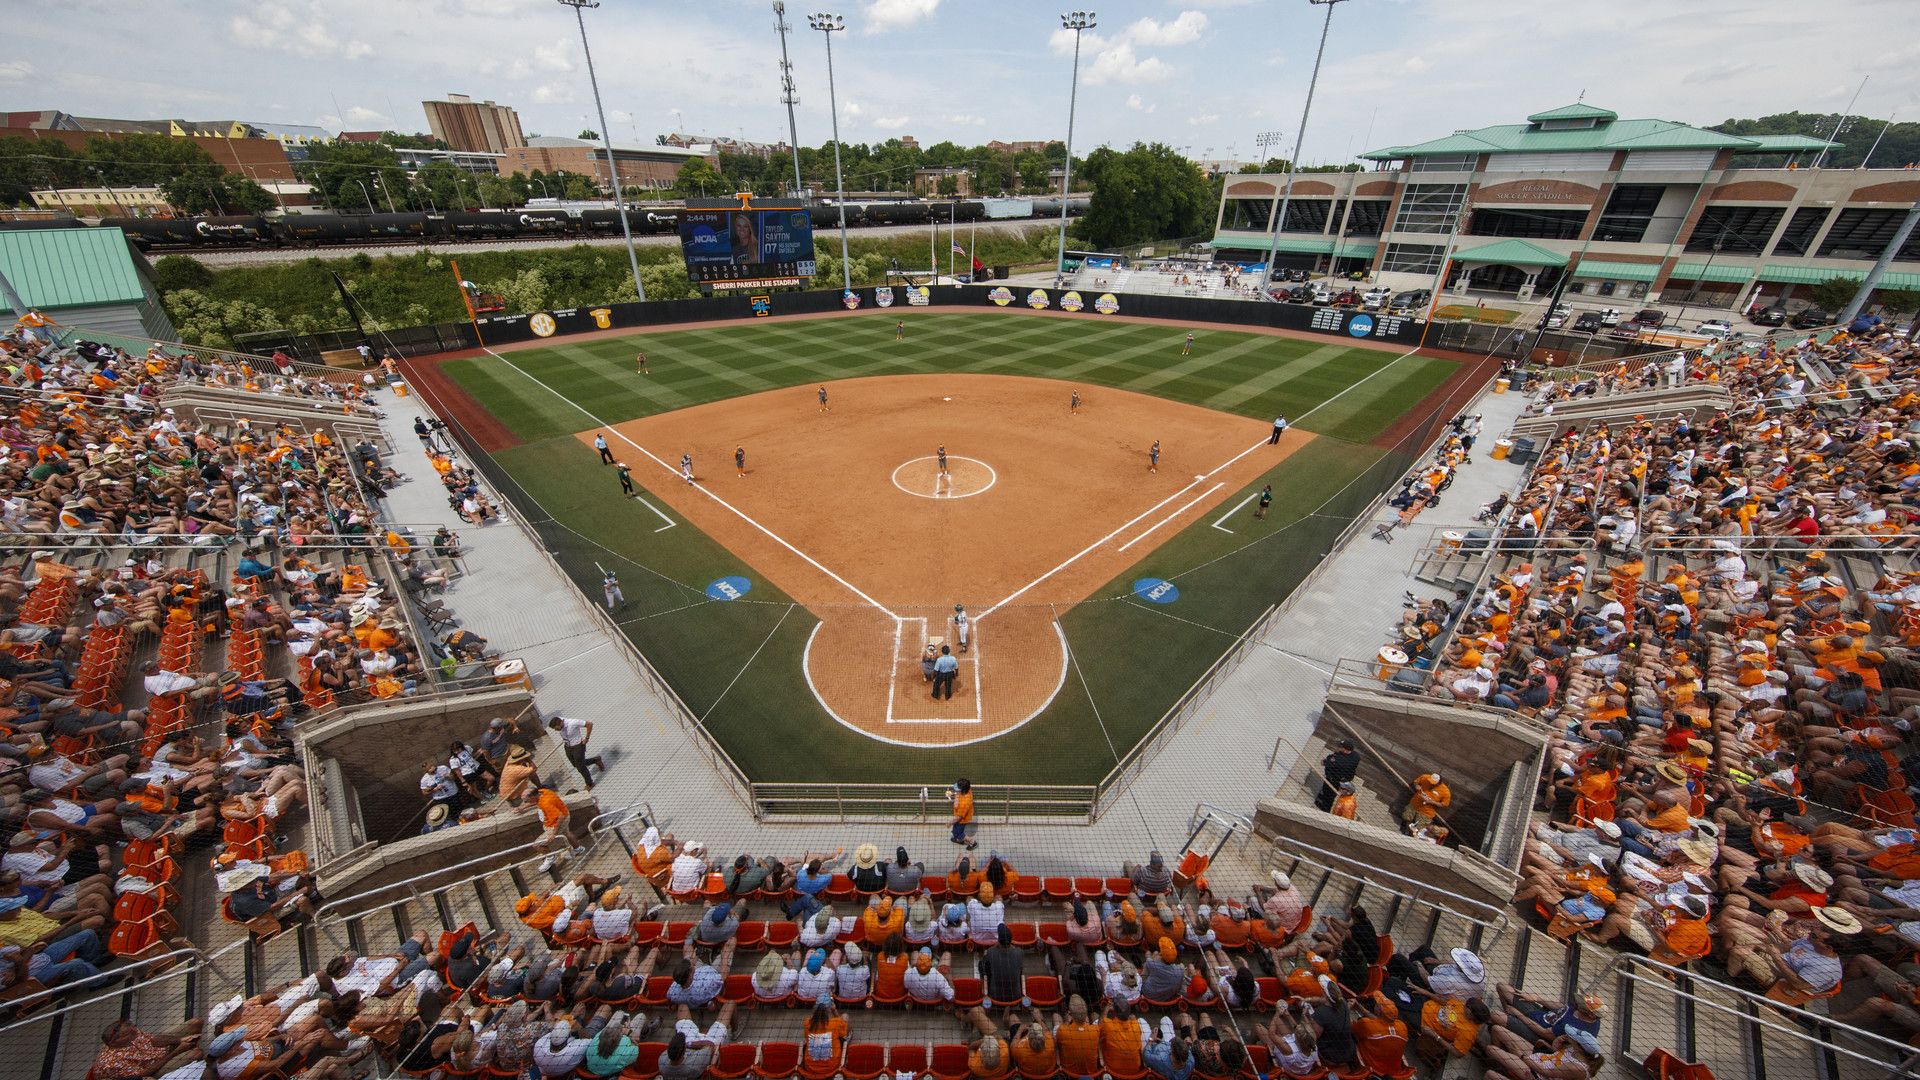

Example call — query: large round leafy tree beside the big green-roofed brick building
[1075,142,1215,248]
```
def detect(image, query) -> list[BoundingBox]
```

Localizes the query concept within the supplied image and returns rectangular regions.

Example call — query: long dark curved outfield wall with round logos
[246,284,1425,363]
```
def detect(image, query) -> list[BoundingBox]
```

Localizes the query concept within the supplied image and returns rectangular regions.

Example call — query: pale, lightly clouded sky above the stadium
[15,0,1920,163]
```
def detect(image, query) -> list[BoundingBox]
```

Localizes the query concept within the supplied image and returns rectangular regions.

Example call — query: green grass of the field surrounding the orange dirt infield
[447,313,1453,784]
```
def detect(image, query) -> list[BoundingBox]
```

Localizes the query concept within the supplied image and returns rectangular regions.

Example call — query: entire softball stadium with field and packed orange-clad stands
[0,0,1920,1080]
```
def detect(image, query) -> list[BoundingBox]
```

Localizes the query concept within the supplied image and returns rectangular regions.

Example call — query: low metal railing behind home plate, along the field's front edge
[749,782,1096,824]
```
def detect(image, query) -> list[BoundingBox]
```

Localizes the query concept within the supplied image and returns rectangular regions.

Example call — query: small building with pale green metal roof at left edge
[0,229,175,340]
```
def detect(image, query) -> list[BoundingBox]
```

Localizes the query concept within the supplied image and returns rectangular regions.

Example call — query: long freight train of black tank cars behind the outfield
[0,194,1089,252]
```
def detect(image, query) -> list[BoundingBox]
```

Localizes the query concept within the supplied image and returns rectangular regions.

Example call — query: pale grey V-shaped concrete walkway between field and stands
[382,357,1523,860]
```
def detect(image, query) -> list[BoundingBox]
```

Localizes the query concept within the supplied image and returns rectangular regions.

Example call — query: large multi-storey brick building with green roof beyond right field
[1213,102,1920,307]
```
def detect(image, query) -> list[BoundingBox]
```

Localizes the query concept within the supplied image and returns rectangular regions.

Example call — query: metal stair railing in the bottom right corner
[1586,953,1914,1080]
